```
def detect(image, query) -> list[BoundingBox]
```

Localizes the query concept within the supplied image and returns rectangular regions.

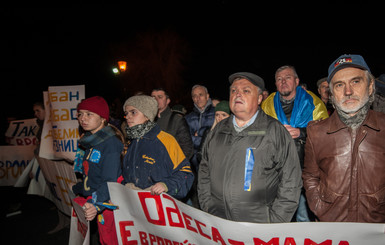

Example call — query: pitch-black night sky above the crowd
[0,4,385,120]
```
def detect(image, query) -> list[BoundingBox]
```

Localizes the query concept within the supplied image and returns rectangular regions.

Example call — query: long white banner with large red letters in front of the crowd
[108,183,385,245]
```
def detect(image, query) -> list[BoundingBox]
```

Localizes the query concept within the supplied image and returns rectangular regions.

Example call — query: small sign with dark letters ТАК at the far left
[5,118,38,145]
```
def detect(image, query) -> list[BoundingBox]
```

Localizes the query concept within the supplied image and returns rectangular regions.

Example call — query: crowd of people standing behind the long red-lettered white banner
[21,55,385,244]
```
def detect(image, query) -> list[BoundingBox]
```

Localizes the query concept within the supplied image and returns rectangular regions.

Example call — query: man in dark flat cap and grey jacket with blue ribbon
[198,72,302,223]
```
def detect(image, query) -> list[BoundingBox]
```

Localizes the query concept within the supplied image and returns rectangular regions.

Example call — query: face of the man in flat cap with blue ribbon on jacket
[230,79,263,120]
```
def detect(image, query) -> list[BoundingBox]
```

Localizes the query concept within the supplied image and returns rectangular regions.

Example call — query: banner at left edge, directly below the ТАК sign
[0,145,36,186]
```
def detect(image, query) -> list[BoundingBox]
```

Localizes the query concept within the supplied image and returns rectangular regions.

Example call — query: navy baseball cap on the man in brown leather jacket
[328,54,370,83]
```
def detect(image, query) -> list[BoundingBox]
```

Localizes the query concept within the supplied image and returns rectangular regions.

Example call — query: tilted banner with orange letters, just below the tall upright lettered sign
[37,157,76,216]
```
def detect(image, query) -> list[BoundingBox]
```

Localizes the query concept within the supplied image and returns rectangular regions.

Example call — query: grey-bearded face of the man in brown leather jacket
[330,67,373,116]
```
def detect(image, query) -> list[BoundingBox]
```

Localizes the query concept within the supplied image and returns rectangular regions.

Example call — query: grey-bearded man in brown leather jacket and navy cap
[303,55,385,223]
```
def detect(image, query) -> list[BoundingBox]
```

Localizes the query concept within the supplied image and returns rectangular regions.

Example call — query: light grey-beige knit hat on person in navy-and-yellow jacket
[123,95,158,122]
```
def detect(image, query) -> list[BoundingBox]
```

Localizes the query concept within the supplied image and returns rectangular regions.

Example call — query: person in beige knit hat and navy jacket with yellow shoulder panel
[121,95,194,199]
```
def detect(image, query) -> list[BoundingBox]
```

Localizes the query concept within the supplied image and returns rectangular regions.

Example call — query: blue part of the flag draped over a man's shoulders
[274,86,315,128]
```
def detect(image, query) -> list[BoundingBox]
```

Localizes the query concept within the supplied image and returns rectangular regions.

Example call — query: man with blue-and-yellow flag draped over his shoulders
[262,65,328,222]
